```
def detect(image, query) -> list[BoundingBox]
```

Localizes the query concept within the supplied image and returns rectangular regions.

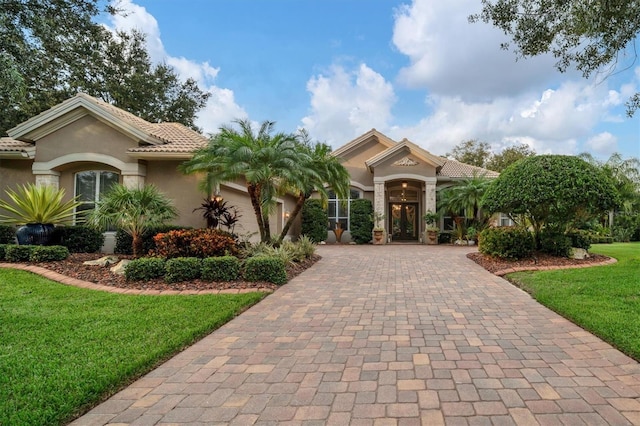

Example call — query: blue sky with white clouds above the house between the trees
[104,0,640,160]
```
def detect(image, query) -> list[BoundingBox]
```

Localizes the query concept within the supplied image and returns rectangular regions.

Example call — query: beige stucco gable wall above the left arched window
[36,116,138,162]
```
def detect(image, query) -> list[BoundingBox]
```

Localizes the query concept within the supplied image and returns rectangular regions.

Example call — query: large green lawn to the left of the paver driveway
[0,269,264,425]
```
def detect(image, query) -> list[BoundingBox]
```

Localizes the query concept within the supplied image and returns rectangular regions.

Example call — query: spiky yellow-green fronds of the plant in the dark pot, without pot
[0,183,80,225]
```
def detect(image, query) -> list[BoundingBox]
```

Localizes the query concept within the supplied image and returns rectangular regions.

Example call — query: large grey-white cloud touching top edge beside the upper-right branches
[393,0,556,100]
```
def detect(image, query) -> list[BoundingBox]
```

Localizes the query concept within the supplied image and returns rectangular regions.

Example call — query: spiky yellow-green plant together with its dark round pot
[0,183,80,245]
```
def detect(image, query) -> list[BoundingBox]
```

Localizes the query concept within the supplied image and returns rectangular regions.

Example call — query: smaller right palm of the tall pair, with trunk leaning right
[278,135,350,243]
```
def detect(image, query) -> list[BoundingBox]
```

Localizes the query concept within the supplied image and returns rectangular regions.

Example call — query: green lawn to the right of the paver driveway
[507,243,640,361]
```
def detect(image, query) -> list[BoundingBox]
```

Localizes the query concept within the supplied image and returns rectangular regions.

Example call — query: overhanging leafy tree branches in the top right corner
[470,0,640,116]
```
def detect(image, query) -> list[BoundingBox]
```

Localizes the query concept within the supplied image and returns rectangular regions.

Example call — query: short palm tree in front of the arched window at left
[87,185,178,257]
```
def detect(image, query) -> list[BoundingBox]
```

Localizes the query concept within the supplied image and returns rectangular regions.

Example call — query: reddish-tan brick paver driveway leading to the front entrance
[73,245,640,426]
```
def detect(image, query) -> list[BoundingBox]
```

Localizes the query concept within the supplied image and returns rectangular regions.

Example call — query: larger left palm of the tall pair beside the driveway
[180,120,308,242]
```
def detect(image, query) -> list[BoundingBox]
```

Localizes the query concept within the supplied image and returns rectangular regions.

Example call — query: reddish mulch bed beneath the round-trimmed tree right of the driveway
[467,252,609,273]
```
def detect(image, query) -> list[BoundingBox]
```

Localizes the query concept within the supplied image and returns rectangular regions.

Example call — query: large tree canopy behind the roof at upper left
[0,0,209,134]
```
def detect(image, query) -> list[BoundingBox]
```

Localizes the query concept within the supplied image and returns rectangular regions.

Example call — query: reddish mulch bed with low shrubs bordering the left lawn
[37,253,320,291]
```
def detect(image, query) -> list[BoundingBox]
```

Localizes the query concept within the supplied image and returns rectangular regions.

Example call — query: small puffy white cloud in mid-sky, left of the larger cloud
[302,64,395,147]
